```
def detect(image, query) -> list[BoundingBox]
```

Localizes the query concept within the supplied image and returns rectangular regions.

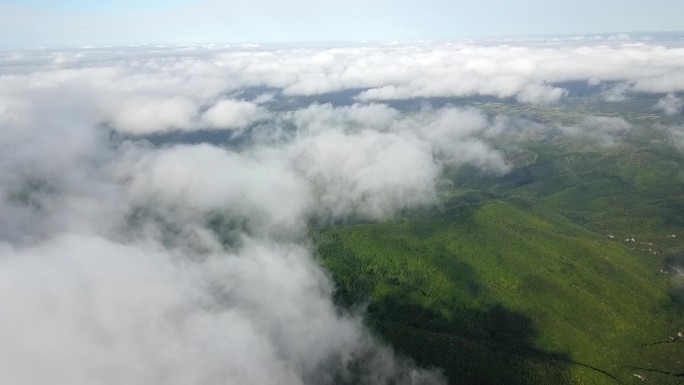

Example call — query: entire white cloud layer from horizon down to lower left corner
[0,38,684,385]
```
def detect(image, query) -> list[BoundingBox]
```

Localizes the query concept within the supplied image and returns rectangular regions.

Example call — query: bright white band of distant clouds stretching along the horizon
[0,40,684,134]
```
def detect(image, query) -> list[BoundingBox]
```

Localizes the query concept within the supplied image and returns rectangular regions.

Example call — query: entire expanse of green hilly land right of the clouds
[312,106,684,385]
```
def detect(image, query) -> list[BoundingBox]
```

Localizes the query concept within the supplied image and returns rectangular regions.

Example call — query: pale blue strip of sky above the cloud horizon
[0,0,684,48]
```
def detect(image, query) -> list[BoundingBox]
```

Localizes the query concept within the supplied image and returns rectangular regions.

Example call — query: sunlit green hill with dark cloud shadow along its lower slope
[316,201,676,384]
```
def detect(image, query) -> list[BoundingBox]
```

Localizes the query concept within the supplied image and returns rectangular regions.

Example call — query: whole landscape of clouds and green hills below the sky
[0,35,684,385]
